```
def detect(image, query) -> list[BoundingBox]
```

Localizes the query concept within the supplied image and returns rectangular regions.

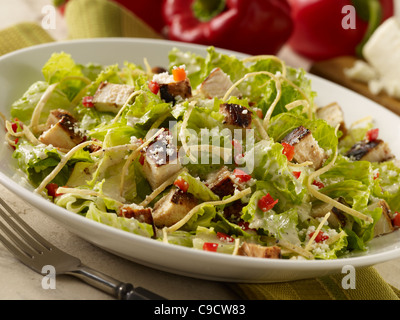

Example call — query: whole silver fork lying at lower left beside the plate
[0,198,165,300]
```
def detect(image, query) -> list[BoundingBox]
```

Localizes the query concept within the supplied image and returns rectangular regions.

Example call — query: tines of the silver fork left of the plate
[0,198,52,256]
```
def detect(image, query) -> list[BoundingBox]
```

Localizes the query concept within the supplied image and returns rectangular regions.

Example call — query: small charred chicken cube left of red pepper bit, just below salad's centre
[205,167,238,199]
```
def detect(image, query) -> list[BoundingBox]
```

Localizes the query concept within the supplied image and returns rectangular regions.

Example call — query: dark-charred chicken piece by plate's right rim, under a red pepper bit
[346,139,394,162]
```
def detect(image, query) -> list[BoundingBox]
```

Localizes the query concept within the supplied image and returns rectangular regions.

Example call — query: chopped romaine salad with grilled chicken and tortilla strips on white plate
[3,47,400,260]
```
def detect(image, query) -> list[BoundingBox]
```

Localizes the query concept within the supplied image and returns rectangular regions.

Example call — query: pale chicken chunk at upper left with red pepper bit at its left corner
[93,82,135,113]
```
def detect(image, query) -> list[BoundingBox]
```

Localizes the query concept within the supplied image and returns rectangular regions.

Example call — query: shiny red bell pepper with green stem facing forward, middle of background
[163,0,293,54]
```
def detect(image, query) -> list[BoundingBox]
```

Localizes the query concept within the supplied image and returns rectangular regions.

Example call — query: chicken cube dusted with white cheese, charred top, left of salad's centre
[142,131,182,190]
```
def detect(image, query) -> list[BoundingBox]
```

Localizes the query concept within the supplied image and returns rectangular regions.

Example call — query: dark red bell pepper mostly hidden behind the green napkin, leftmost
[53,0,165,33]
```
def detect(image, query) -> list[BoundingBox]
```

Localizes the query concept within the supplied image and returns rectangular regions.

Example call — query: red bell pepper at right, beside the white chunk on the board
[289,0,394,60]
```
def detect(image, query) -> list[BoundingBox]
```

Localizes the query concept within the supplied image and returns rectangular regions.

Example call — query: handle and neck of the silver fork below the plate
[68,265,165,300]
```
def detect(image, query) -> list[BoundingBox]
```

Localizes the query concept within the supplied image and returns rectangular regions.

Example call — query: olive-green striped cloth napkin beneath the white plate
[0,0,400,300]
